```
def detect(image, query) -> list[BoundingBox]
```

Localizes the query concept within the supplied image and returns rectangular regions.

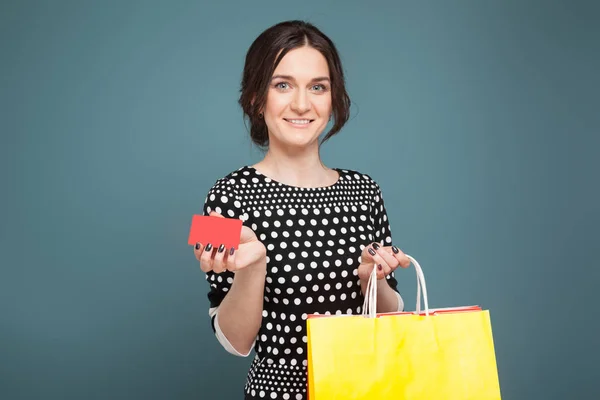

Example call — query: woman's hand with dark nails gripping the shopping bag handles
[358,243,410,282]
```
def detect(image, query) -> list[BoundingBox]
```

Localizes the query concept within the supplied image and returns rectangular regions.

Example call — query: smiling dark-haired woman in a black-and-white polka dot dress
[194,21,410,399]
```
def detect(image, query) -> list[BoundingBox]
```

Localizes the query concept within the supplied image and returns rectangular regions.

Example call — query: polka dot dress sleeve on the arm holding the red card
[203,178,253,356]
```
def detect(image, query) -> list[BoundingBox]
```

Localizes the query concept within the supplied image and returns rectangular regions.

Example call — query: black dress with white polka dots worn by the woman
[204,166,397,400]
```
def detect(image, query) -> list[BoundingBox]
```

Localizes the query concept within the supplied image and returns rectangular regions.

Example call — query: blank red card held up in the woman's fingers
[188,215,242,250]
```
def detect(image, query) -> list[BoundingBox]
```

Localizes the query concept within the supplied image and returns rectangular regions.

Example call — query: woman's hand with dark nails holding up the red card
[194,211,267,274]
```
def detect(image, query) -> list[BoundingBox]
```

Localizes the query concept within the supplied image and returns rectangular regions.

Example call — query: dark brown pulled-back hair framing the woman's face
[239,20,350,148]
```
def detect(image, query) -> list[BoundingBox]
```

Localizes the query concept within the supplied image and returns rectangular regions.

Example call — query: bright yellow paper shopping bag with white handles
[307,256,500,400]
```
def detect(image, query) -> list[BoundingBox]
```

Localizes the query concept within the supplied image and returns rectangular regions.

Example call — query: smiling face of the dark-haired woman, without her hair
[264,46,331,147]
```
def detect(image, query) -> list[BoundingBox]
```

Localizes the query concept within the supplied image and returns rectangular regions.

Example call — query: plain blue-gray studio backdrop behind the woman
[0,0,600,399]
